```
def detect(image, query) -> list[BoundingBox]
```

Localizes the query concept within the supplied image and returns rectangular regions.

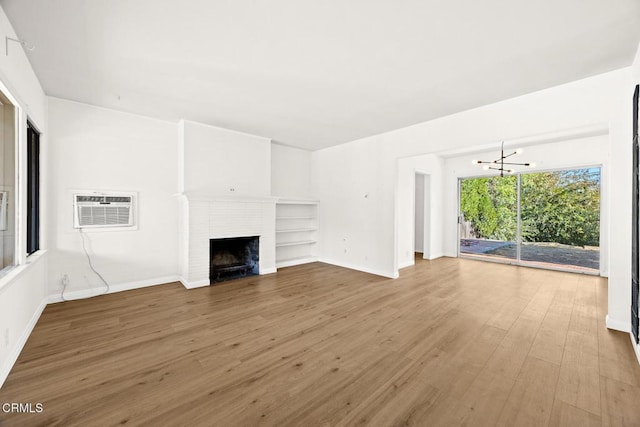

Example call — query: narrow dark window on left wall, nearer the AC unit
[27,123,40,255]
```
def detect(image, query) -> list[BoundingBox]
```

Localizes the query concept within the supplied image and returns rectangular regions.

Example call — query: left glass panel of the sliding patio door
[459,175,518,261]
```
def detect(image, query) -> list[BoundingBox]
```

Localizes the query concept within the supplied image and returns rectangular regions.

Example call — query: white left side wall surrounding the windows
[0,4,47,392]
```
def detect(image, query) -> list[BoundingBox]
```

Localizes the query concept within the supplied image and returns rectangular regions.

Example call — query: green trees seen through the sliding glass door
[460,168,600,246]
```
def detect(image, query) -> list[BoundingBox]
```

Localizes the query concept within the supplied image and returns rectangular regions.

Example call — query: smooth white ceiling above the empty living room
[0,0,640,149]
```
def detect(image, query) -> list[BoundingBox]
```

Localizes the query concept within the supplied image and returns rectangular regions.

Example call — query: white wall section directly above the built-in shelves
[271,143,313,199]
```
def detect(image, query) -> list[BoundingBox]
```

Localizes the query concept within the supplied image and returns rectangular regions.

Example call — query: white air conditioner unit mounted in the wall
[73,194,134,228]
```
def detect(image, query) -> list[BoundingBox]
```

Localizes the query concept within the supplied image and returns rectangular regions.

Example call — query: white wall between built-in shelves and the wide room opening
[312,140,392,277]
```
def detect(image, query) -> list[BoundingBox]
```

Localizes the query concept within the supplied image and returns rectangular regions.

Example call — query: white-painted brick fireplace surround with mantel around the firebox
[178,192,278,289]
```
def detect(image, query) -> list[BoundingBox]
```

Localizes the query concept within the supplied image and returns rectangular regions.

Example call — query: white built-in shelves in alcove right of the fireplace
[276,200,318,267]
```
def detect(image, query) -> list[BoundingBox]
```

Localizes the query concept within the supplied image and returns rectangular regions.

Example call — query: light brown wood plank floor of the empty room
[0,258,640,426]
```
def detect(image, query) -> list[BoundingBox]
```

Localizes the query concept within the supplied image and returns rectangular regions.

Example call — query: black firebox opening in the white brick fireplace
[209,236,260,284]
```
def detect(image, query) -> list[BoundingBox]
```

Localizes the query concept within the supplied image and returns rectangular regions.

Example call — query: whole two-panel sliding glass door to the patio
[459,167,600,273]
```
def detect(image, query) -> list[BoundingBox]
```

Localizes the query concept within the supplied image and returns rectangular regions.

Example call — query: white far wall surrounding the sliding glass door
[444,134,611,276]
